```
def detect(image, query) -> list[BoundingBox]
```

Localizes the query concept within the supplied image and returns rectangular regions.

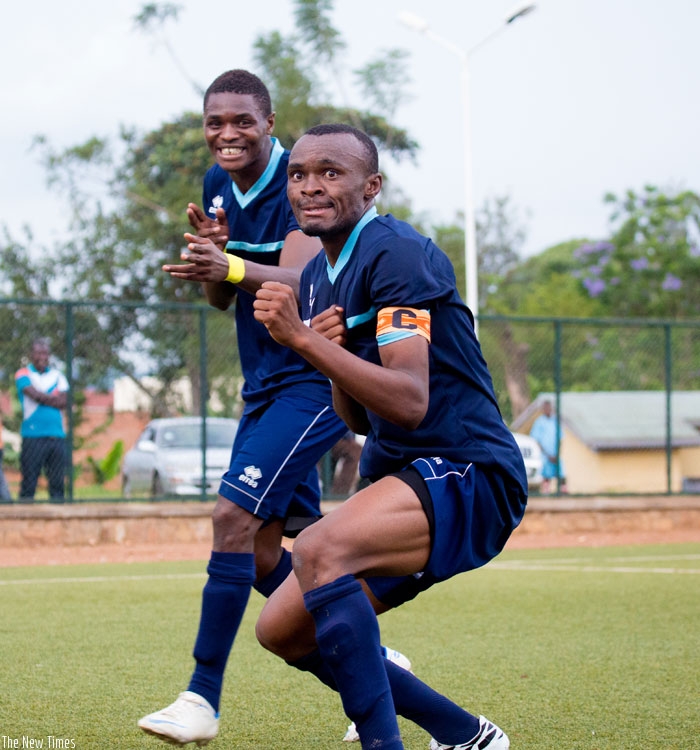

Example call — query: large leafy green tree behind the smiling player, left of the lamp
[2,0,417,414]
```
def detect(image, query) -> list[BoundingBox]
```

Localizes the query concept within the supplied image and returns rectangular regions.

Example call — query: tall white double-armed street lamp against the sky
[399,3,536,331]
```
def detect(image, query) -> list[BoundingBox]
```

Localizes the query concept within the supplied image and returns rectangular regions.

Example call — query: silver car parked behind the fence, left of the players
[122,417,238,497]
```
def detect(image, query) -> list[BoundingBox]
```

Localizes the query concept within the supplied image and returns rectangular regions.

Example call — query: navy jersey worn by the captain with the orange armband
[301,209,527,492]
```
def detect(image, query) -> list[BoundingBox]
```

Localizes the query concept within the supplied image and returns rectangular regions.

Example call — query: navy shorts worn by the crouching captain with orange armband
[366,458,527,607]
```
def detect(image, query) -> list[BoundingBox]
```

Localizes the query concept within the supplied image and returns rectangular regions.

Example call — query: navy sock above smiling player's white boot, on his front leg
[187,552,255,713]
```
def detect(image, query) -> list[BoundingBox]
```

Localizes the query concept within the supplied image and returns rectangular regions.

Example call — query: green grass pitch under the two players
[0,544,700,750]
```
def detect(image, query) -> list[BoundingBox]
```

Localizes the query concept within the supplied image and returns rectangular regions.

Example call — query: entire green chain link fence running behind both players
[0,299,700,502]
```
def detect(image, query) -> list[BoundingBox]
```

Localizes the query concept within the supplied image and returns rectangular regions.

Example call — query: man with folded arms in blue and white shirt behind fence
[15,338,68,502]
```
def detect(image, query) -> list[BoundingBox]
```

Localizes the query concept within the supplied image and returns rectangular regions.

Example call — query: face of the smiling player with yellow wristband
[204,93,275,179]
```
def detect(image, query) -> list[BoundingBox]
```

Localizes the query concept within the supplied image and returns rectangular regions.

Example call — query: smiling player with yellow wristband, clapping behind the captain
[138,70,405,744]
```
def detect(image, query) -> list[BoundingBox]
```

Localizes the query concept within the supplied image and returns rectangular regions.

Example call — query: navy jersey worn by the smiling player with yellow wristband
[202,138,330,412]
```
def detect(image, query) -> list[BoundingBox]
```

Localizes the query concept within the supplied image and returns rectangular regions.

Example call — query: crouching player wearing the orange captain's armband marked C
[255,124,527,750]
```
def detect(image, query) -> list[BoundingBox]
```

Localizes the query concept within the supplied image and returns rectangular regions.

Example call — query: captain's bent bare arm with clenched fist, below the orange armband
[255,282,429,430]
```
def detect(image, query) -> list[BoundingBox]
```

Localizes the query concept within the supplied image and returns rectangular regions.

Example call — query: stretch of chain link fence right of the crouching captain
[480,316,700,495]
